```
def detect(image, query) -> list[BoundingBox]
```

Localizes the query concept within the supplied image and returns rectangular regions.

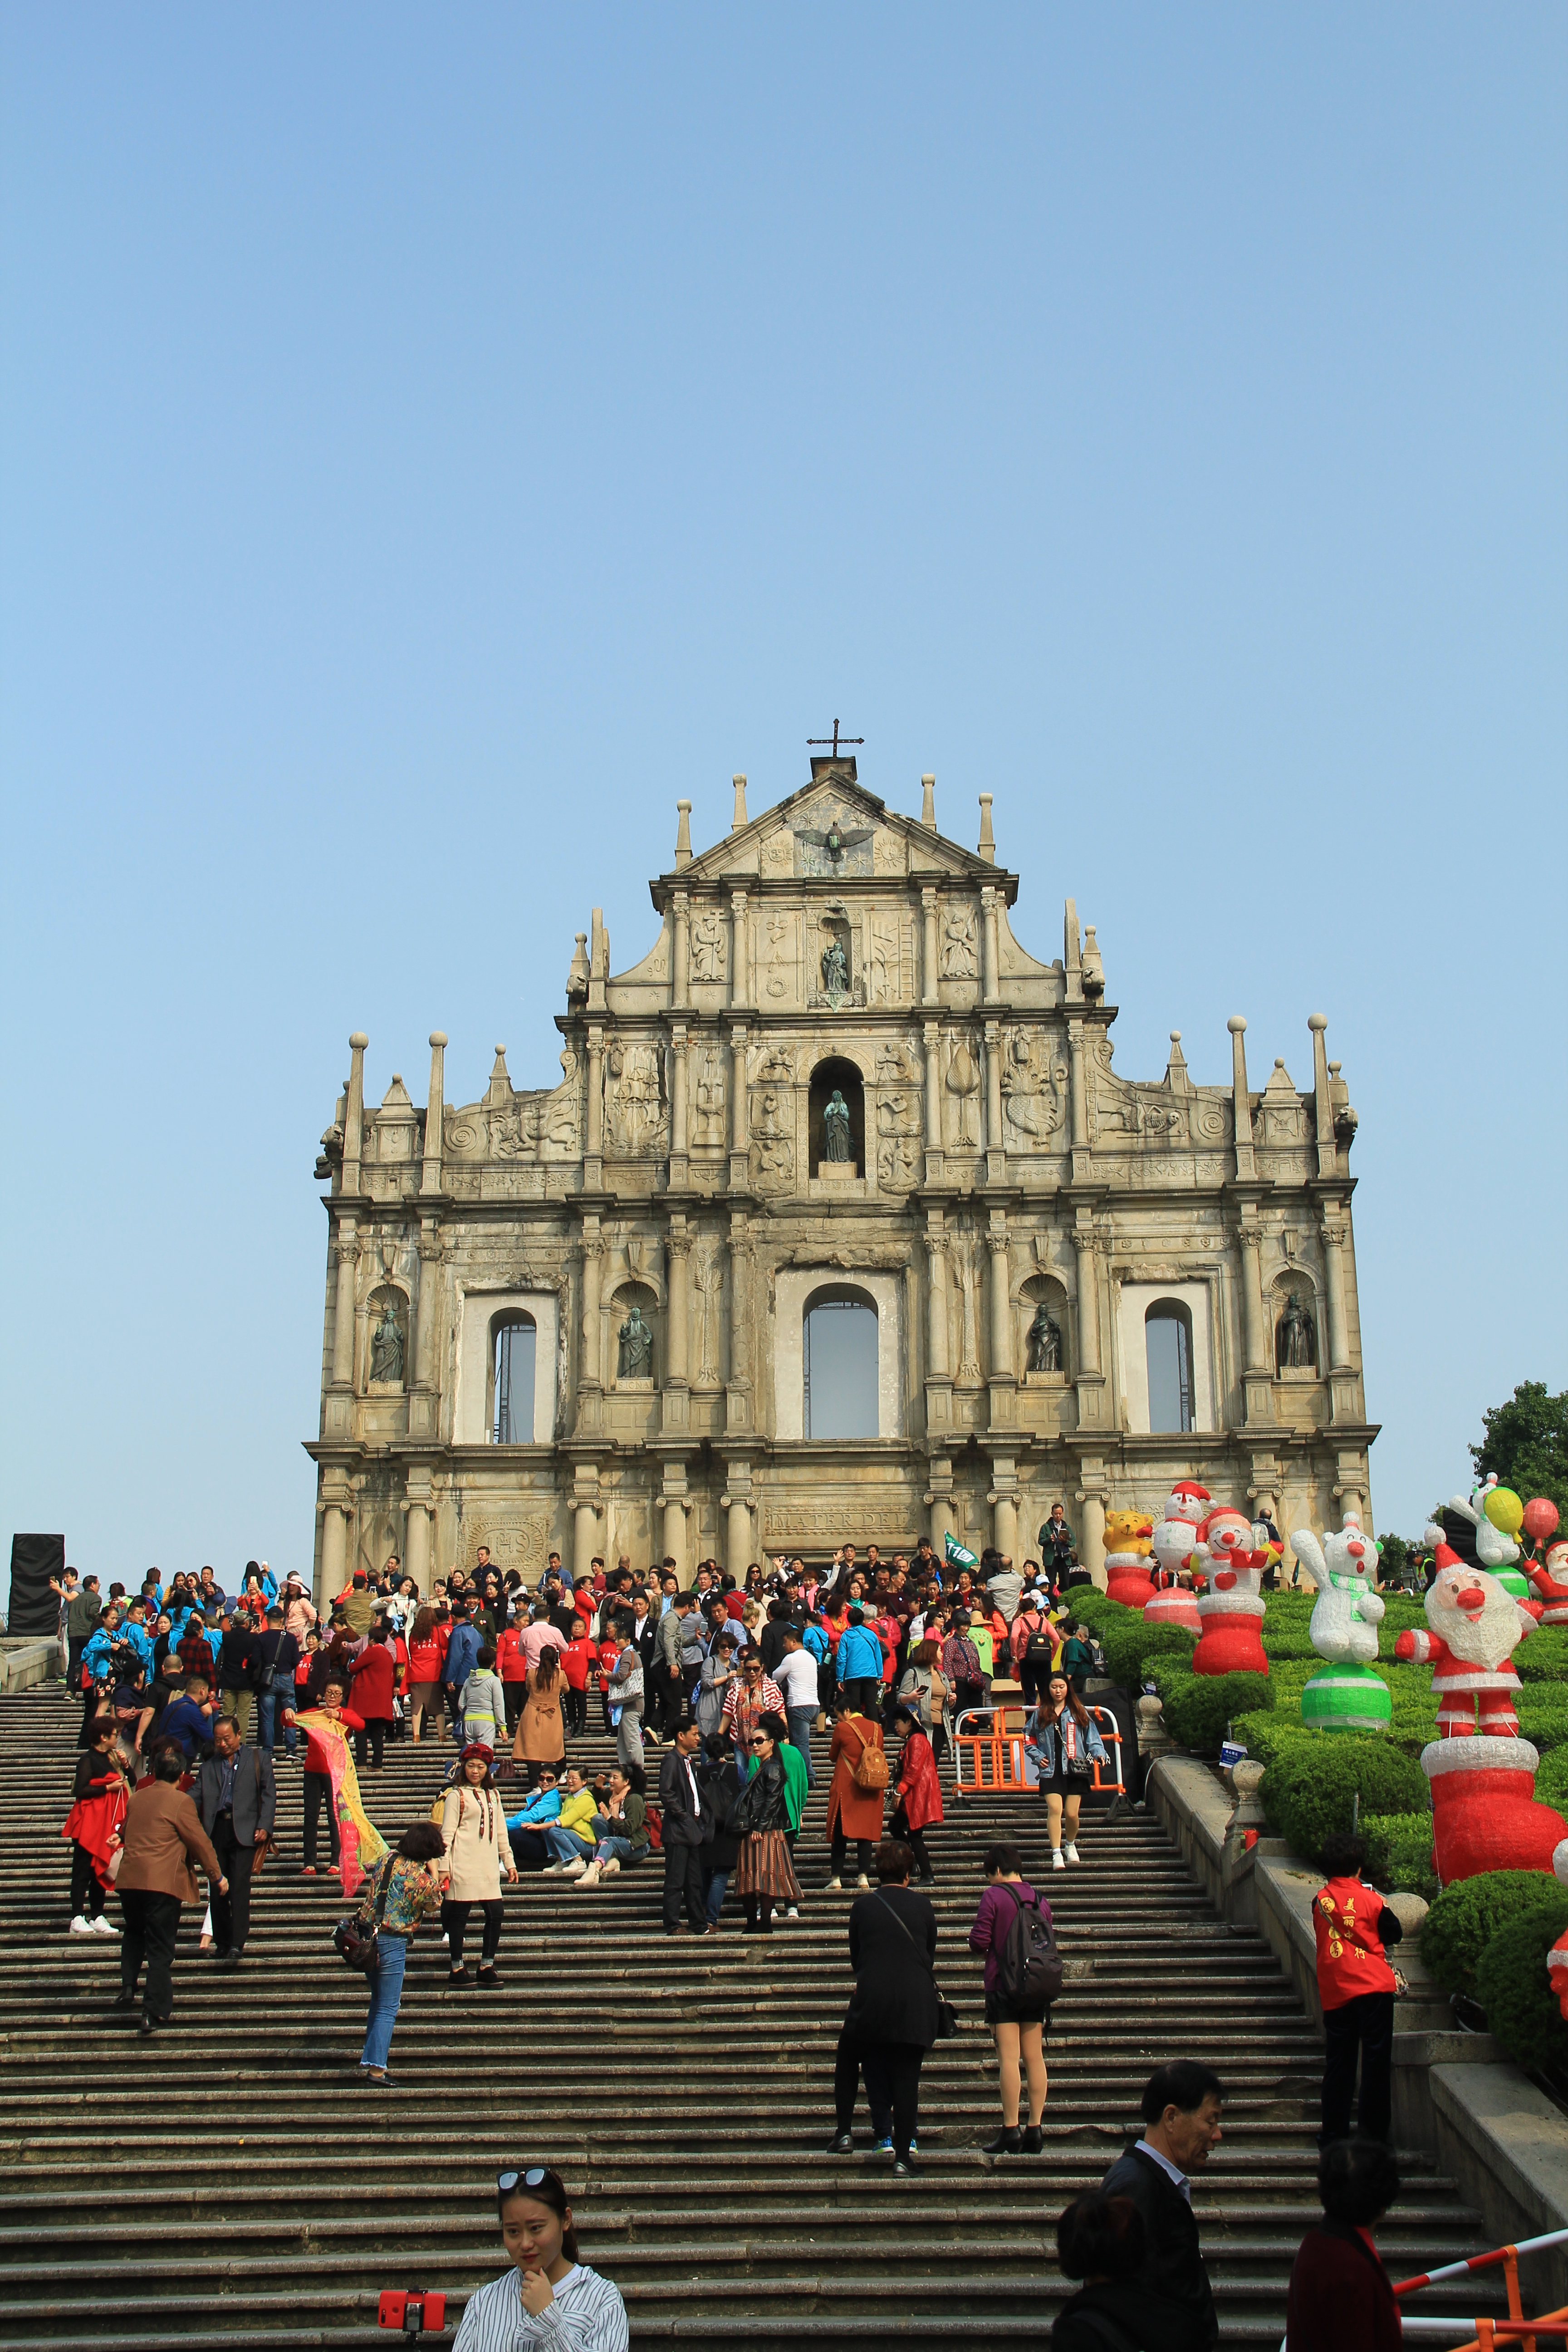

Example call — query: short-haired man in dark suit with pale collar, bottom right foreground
[1100,2058,1225,2352]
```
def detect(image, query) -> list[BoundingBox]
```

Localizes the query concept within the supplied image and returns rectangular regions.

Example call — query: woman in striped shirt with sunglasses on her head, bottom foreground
[451,2164,627,2352]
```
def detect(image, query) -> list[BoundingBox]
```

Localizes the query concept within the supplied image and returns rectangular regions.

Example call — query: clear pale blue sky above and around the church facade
[0,5,1568,1576]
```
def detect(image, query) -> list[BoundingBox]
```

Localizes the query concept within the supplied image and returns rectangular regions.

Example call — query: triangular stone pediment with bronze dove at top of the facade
[661,760,999,889]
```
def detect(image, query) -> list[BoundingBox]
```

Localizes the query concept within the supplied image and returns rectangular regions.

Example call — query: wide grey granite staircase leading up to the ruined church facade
[0,1684,1483,2352]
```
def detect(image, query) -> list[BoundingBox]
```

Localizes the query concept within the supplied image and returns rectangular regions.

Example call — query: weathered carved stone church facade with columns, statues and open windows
[308,757,1375,1590]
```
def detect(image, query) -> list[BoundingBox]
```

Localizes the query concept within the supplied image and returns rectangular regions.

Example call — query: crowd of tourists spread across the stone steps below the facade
[46,1533,1399,2352]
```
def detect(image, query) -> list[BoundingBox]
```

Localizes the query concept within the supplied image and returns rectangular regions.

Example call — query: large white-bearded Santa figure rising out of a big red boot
[1394,1543,1568,1886]
